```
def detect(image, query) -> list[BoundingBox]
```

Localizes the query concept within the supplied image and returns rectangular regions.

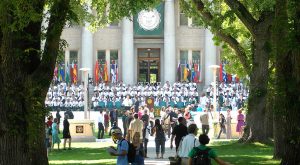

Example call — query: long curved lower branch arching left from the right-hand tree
[193,0,250,74]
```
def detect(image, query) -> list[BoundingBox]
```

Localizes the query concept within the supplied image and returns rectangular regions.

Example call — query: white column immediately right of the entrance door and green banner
[163,0,176,83]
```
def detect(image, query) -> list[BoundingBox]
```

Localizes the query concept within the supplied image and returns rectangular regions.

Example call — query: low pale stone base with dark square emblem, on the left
[68,119,96,142]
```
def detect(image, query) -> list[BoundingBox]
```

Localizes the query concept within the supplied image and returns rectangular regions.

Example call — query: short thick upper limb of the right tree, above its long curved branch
[225,0,257,35]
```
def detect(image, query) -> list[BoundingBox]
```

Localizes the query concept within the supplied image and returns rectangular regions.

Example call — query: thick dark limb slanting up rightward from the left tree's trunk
[31,0,70,89]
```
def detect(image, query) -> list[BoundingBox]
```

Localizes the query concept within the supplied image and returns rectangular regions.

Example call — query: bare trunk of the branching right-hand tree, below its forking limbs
[246,21,270,142]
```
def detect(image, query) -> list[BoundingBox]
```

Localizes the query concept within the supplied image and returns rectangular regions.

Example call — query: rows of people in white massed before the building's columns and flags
[45,82,249,114]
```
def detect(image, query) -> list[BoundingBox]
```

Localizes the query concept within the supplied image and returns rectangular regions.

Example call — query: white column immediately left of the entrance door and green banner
[122,18,135,84]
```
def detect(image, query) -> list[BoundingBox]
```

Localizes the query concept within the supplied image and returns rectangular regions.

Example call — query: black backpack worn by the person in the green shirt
[192,147,211,165]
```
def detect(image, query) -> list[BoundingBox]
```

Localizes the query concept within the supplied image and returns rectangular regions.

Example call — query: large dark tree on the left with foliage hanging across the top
[0,0,157,165]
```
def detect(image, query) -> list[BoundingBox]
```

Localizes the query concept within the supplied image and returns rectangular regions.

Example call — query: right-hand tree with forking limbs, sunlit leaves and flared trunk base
[180,0,274,142]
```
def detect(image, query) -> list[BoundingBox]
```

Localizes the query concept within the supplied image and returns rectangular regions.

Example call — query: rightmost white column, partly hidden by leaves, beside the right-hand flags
[205,29,217,86]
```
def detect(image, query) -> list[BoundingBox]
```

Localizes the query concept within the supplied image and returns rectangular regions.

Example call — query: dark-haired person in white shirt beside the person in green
[178,124,200,165]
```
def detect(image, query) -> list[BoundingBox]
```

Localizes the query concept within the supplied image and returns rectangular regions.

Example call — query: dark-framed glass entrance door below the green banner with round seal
[137,48,160,83]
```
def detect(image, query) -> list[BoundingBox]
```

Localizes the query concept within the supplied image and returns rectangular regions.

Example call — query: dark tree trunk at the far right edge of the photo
[273,0,300,162]
